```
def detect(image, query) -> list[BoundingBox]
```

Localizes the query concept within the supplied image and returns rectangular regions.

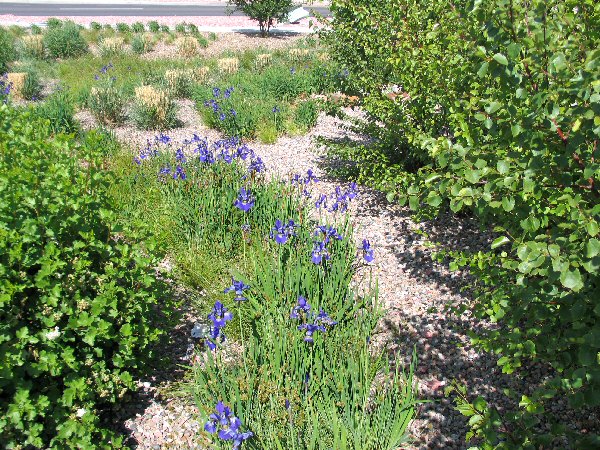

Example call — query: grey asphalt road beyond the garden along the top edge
[0,3,329,17]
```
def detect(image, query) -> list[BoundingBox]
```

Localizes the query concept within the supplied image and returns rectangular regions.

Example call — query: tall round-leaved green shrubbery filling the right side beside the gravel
[329,0,600,448]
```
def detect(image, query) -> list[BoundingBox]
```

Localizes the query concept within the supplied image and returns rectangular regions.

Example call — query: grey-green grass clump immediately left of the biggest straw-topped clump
[87,63,127,125]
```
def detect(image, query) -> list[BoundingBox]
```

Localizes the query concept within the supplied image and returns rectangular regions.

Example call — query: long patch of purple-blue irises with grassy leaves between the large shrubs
[120,135,415,450]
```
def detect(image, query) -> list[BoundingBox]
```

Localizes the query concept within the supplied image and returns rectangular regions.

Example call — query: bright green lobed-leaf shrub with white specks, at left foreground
[0,106,166,448]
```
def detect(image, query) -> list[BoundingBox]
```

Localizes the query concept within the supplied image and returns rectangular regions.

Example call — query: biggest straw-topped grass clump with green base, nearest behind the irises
[132,85,178,130]
